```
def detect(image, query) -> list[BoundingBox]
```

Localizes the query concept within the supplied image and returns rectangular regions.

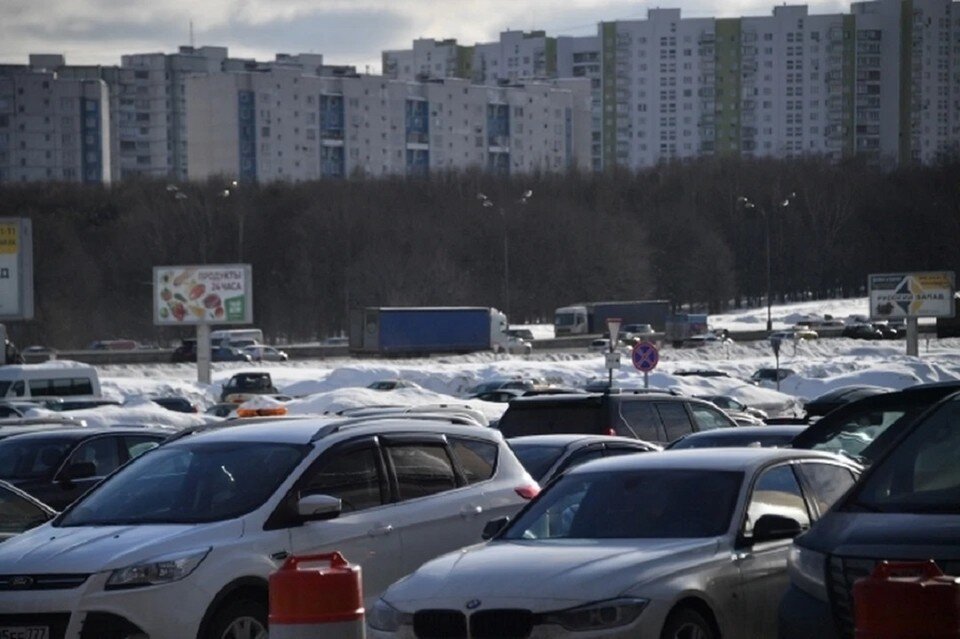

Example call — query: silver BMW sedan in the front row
[367,448,859,639]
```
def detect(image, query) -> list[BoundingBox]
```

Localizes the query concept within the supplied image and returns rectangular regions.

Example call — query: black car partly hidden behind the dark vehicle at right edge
[791,382,960,465]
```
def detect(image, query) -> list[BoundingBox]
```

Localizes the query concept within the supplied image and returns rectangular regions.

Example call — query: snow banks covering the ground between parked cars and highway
[41,298,960,428]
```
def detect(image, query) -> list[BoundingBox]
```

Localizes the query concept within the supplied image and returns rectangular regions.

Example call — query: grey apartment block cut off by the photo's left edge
[0,55,110,183]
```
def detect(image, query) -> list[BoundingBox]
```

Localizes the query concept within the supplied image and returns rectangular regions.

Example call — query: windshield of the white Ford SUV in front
[57,442,309,526]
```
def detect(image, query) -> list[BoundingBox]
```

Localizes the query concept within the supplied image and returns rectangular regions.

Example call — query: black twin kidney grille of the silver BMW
[413,609,533,639]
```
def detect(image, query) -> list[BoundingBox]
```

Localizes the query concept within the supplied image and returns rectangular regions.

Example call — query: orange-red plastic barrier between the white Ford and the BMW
[270,552,366,639]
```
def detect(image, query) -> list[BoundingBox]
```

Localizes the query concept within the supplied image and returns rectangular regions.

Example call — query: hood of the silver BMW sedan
[385,538,718,610]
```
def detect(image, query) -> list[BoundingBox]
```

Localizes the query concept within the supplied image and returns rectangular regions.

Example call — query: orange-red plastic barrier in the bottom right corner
[853,561,960,639]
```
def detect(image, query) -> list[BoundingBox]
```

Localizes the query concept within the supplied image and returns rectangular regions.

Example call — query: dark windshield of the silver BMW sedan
[500,469,743,540]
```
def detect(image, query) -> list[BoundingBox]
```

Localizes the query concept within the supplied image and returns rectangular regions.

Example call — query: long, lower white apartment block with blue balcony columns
[186,67,590,181]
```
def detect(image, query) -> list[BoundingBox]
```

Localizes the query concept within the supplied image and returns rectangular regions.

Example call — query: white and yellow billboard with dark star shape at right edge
[867,271,955,319]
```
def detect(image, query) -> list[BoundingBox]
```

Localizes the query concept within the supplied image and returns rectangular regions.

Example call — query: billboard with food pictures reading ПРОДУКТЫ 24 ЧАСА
[153,264,253,326]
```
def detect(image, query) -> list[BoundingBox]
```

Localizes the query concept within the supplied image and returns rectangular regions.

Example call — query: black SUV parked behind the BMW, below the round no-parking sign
[497,390,737,445]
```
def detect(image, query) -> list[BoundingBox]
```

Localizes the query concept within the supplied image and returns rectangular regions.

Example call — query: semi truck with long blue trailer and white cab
[350,306,510,356]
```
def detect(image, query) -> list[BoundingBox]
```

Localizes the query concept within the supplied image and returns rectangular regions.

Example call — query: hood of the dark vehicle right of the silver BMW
[798,511,960,560]
